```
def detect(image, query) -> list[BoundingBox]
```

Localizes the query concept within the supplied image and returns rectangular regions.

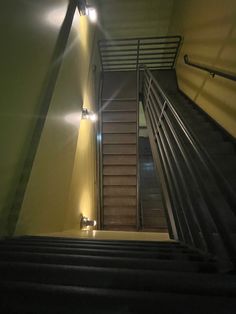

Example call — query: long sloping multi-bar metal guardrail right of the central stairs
[142,67,236,267]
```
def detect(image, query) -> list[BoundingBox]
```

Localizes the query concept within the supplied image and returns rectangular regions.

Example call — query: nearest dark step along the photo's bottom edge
[1,281,236,314]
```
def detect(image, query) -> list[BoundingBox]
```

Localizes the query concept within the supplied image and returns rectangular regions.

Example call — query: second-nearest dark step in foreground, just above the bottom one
[0,262,236,297]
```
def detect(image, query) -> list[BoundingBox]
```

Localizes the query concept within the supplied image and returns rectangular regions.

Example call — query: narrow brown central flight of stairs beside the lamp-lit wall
[101,71,137,231]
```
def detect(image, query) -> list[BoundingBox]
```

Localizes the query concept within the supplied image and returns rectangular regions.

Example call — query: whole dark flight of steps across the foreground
[0,237,236,314]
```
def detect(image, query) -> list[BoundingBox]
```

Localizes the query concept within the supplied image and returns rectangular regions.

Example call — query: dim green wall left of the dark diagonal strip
[0,0,67,235]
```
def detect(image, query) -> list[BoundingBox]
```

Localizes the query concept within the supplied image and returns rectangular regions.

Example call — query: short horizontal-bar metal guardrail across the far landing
[98,36,181,71]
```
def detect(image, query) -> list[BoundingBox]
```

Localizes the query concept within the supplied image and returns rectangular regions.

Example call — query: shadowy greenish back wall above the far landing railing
[99,0,174,39]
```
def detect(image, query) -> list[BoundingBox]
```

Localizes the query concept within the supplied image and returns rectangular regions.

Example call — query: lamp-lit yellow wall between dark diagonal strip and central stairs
[15,2,98,235]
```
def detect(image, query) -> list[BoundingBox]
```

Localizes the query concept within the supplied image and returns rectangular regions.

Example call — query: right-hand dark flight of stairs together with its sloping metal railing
[143,67,236,262]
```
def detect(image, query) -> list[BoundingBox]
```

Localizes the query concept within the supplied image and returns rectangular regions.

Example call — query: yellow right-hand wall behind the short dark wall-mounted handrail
[169,0,236,137]
